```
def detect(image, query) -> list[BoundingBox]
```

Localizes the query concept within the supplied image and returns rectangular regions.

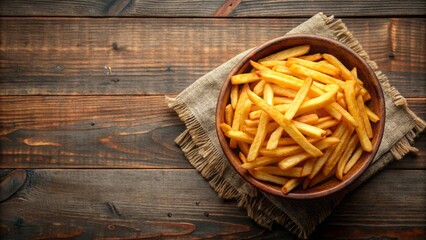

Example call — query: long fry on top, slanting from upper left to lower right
[247,90,322,157]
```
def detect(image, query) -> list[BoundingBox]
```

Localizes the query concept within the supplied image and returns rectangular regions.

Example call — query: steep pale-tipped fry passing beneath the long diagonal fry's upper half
[247,84,274,162]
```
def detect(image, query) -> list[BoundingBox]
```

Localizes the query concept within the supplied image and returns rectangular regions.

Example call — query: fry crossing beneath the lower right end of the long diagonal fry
[278,137,340,170]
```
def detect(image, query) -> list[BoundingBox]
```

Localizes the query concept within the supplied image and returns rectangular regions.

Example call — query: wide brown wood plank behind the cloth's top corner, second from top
[0,18,426,97]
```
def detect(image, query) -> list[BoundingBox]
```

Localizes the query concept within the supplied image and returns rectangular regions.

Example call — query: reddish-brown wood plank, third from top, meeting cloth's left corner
[0,96,426,169]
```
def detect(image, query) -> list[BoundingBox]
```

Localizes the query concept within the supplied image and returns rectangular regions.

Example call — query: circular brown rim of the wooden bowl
[215,34,386,199]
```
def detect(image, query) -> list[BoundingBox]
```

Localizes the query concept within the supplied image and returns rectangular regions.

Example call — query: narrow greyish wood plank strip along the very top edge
[0,0,426,17]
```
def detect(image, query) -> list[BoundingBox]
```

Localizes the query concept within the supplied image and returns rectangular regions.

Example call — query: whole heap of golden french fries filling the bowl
[220,45,380,194]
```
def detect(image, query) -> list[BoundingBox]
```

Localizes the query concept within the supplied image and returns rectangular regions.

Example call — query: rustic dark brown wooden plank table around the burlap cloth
[0,0,426,239]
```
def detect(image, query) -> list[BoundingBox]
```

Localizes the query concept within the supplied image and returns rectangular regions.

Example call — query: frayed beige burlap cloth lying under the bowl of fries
[166,13,425,238]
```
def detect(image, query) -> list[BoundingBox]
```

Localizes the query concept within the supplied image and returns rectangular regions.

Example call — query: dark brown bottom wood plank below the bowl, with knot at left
[0,169,426,239]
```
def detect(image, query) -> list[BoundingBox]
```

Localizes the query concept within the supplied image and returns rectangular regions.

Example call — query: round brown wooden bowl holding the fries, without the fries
[216,34,385,199]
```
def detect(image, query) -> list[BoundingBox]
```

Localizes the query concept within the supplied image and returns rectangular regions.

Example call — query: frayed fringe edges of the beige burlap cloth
[166,14,426,238]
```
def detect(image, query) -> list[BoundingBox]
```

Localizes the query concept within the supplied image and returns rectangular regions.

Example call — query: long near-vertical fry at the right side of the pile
[343,81,373,152]
